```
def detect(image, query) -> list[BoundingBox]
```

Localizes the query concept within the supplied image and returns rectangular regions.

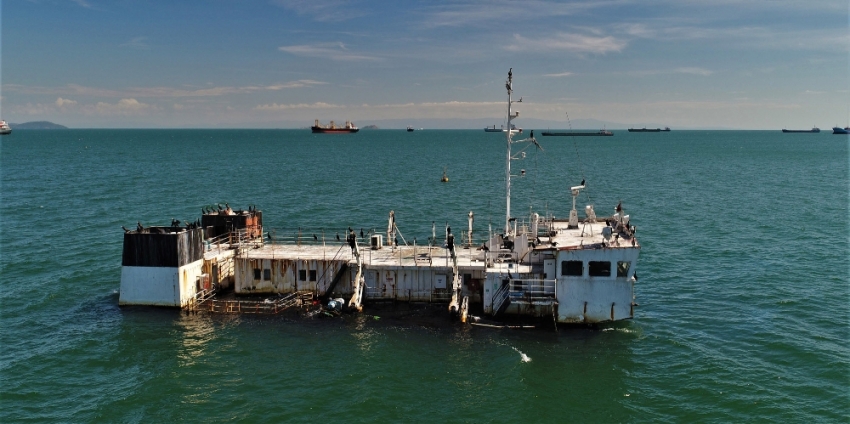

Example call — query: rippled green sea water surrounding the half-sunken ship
[0,130,850,423]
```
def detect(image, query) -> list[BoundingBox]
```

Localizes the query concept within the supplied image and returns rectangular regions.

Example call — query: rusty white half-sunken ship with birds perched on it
[120,73,640,323]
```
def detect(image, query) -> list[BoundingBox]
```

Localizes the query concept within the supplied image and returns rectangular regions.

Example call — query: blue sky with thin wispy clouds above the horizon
[0,0,850,129]
